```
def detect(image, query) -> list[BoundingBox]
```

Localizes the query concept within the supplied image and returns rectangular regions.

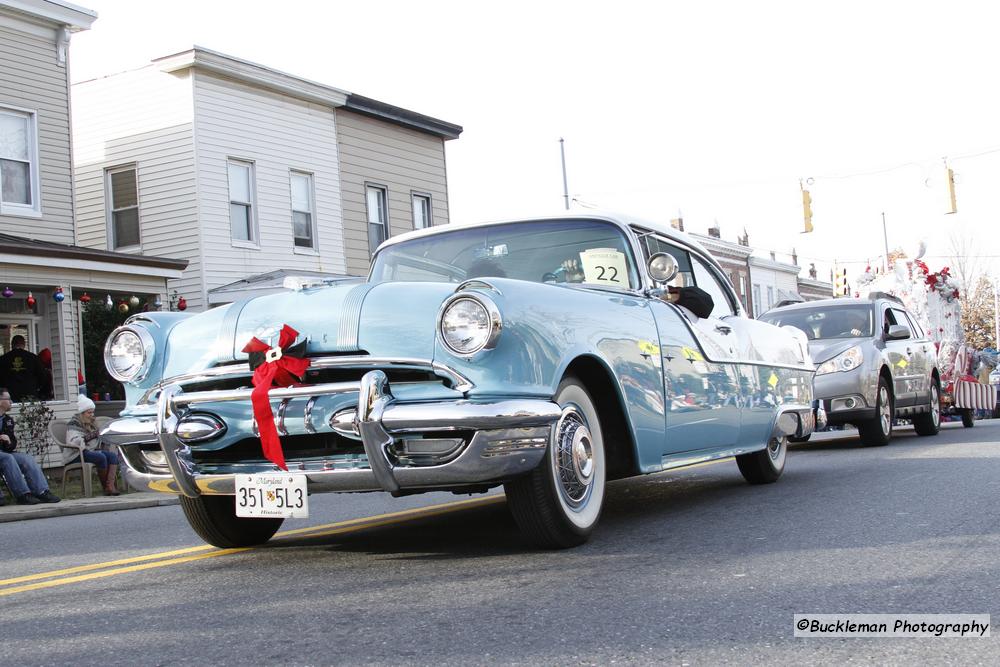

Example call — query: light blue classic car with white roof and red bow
[104,214,825,548]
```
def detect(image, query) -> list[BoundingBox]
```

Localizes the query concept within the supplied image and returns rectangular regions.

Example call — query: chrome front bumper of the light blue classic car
[111,370,560,498]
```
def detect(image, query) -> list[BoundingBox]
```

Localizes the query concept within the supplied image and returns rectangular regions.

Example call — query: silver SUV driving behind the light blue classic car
[759,292,941,445]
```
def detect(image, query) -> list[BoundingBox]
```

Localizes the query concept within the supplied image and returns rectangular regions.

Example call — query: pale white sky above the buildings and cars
[71,0,1000,278]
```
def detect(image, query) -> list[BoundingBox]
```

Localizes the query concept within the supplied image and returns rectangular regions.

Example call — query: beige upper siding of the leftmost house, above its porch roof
[0,16,73,243]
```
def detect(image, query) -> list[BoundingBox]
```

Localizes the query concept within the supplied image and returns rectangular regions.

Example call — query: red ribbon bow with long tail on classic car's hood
[243,324,309,470]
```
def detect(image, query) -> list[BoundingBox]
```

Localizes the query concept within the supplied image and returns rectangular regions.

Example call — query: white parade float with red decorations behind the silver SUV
[855,250,997,427]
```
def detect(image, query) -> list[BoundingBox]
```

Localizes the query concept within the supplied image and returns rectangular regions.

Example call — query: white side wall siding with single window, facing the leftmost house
[73,66,202,306]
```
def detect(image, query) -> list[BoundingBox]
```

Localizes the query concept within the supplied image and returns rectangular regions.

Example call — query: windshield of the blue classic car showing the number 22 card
[371,220,639,288]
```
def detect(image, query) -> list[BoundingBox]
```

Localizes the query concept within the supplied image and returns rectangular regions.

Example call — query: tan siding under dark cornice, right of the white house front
[337,109,448,275]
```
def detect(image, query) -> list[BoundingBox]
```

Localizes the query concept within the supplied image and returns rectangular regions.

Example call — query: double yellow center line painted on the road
[0,496,505,597]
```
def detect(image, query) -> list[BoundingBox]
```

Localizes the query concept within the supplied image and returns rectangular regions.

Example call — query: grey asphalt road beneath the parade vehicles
[0,421,1000,665]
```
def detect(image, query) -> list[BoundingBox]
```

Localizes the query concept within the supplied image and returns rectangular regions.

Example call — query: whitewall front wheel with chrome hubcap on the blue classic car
[504,377,607,549]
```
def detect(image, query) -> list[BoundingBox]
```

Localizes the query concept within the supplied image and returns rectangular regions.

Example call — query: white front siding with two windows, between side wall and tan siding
[189,71,345,307]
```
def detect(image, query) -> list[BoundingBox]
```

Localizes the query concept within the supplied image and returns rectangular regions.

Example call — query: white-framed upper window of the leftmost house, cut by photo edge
[0,107,42,215]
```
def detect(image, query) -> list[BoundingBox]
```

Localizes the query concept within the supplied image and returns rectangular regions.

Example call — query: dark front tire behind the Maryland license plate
[181,496,284,549]
